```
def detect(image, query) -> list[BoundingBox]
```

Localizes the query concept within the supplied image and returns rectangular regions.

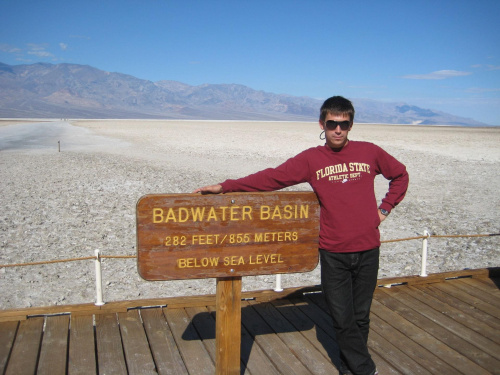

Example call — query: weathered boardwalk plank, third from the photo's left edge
[37,315,70,375]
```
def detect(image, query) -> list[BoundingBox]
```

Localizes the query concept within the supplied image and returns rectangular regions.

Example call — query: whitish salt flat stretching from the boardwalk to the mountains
[0,120,500,309]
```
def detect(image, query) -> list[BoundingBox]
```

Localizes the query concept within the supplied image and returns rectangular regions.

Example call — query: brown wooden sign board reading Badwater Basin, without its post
[137,192,319,280]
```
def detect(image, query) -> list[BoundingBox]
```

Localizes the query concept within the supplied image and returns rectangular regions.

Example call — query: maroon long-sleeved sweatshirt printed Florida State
[221,141,409,253]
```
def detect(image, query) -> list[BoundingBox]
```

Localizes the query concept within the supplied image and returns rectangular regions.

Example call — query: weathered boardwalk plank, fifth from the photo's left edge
[95,314,127,374]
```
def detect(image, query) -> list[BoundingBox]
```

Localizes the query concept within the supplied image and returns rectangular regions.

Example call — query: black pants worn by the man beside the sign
[320,248,379,375]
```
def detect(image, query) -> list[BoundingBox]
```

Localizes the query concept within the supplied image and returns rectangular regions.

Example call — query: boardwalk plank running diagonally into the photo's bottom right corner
[375,287,498,369]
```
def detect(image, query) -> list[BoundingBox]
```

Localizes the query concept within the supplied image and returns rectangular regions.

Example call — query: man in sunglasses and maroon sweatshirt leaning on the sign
[194,96,409,375]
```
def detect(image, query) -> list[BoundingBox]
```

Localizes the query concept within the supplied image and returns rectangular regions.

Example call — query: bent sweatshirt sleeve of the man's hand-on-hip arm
[377,146,410,212]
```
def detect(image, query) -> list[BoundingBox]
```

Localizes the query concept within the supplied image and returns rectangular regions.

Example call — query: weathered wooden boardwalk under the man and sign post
[0,268,500,375]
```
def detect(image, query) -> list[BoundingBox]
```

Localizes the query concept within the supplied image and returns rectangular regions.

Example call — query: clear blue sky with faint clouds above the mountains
[0,0,500,125]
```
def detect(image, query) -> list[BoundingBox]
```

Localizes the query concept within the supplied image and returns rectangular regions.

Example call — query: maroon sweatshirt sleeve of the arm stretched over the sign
[221,150,309,193]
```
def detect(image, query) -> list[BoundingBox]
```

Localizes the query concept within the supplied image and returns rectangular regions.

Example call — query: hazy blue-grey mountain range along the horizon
[0,63,486,126]
